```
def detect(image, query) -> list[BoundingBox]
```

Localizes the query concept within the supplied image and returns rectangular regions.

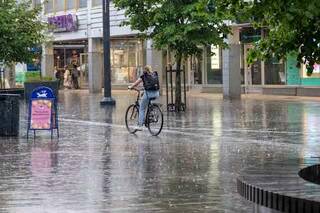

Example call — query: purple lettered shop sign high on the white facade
[48,14,78,32]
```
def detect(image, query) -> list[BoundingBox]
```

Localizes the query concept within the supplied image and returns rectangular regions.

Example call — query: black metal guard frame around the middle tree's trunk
[166,65,187,112]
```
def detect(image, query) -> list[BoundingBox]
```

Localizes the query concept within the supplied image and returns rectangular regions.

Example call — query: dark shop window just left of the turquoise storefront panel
[264,59,286,84]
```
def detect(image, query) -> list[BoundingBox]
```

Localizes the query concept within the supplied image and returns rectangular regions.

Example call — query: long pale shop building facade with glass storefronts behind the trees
[34,0,320,92]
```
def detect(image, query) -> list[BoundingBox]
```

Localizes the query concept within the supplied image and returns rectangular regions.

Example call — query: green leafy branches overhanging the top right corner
[226,0,320,73]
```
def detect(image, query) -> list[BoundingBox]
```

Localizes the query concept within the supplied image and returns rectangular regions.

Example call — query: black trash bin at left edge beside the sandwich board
[0,94,20,136]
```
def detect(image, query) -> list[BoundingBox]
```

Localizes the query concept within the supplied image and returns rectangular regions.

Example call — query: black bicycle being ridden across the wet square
[125,88,163,136]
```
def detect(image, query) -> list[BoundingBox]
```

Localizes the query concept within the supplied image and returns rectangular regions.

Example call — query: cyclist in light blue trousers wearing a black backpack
[128,65,160,131]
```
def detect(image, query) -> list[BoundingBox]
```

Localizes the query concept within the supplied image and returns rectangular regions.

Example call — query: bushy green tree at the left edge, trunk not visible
[0,0,46,64]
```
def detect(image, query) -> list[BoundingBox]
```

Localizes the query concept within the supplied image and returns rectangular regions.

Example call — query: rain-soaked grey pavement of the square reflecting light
[0,91,320,213]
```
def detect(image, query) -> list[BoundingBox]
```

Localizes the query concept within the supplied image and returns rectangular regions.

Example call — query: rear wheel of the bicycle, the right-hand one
[146,105,163,136]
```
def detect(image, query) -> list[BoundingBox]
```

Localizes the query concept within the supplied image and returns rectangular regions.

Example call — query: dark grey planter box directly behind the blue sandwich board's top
[24,81,59,101]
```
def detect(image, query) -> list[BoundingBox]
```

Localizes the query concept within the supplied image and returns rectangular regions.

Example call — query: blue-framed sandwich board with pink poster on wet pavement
[27,86,59,138]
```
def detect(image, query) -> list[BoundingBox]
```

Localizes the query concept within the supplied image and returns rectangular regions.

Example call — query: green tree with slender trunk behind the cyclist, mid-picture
[113,0,230,110]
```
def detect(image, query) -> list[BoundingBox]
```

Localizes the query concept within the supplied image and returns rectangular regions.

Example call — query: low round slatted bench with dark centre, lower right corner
[237,158,320,213]
